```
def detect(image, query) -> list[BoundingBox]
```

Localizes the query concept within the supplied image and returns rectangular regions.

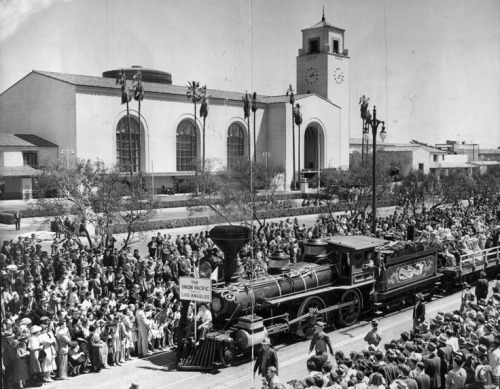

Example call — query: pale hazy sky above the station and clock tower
[0,0,500,148]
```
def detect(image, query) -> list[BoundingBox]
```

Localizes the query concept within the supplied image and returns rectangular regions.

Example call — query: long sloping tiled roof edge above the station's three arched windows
[33,70,278,103]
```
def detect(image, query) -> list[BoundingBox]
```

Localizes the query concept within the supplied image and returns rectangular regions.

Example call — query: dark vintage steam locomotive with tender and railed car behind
[177,226,500,370]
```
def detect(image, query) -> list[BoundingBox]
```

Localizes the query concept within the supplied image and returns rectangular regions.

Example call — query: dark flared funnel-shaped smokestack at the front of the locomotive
[210,226,252,283]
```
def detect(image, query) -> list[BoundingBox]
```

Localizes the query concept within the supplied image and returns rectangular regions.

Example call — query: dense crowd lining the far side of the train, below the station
[0,197,500,389]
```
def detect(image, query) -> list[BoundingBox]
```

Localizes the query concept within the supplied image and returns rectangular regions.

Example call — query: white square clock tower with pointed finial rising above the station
[297,12,350,137]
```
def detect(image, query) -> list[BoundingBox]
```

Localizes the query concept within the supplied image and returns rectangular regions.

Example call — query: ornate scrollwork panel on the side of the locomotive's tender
[387,255,436,289]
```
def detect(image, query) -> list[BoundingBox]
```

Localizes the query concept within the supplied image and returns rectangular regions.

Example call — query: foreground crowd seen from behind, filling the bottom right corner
[257,278,500,389]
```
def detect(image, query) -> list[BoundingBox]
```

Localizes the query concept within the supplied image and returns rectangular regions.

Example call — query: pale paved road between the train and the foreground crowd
[32,284,472,389]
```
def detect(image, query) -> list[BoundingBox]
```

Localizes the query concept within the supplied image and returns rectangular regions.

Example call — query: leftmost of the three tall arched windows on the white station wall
[116,116,141,173]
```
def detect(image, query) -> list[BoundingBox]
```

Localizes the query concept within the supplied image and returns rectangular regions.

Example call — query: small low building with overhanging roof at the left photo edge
[0,133,58,200]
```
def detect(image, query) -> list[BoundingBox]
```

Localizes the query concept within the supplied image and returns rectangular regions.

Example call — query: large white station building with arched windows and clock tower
[0,17,350,193]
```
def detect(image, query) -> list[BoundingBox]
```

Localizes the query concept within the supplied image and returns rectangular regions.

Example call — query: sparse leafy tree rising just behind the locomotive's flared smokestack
[185,159,283,230]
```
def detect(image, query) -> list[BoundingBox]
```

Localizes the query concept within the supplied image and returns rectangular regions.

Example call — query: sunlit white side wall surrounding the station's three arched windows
[76,93,266,174]
